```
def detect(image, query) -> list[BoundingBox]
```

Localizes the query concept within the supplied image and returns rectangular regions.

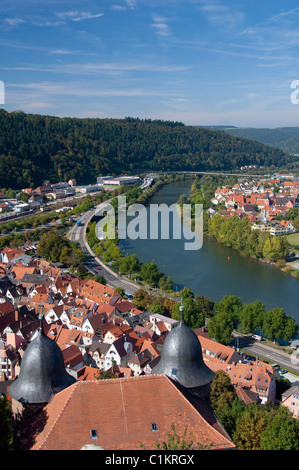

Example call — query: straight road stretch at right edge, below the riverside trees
[234,334,299,381]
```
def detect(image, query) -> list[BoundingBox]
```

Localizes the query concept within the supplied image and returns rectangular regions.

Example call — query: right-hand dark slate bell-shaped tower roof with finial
[153,303,214,388]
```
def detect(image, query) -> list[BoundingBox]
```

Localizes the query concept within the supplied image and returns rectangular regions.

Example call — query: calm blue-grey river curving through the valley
[121,180,299,324]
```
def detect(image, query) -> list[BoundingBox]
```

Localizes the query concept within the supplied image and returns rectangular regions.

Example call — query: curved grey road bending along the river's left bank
[68,200,140,295]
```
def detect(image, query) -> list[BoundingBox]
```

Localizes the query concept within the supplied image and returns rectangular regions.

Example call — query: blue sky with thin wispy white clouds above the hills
[0,0,299,127]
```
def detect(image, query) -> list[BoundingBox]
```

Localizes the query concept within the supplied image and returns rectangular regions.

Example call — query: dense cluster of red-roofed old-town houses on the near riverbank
[0,237,299,448]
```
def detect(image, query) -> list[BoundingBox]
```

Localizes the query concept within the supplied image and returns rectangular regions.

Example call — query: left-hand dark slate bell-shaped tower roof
[9,319,76,404]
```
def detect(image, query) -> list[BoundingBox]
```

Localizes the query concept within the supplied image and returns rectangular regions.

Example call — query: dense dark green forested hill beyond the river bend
[0,110,293,189]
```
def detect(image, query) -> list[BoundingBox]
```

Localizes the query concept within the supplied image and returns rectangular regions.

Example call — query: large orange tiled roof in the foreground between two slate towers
[22,375,235,450]
